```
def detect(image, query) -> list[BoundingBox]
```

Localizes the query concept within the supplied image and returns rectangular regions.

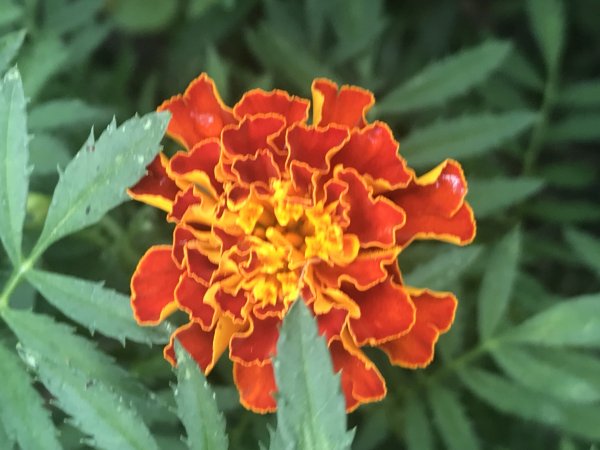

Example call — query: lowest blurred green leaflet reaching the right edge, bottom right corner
[459,369,600,441]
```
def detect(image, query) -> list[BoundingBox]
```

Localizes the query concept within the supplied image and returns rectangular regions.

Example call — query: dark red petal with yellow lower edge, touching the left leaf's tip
[127,153,179,212]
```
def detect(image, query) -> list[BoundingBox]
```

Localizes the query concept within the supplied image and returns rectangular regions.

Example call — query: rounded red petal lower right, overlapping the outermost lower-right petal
[344,280,415,347]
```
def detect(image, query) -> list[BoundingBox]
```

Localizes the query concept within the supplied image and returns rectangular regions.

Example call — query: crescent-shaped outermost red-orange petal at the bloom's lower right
[379,289,457,369]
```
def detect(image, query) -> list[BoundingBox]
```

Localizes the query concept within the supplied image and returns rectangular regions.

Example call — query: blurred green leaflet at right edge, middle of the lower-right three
[492,345,600,404]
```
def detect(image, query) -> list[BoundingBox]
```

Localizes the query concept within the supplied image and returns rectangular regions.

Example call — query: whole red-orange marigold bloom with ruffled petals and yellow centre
[130,74,475,413]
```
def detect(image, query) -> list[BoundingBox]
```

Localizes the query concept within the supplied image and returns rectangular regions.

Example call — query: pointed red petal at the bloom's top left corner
[158,73,235,149]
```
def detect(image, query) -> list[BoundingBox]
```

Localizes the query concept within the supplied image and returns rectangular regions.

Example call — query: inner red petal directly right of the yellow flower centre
[337,169,405,247]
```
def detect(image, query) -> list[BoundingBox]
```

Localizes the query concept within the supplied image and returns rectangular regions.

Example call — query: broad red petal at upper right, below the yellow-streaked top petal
[331,122,413,190]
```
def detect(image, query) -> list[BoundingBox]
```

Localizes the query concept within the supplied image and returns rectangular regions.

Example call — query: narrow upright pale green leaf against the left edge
[0,68,29,265]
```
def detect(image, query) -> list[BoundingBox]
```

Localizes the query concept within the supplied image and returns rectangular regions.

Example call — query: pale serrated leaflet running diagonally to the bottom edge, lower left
[21,348,158,450]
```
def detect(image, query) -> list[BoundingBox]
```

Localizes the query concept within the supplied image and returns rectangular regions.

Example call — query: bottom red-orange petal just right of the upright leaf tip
[329,334,387,412]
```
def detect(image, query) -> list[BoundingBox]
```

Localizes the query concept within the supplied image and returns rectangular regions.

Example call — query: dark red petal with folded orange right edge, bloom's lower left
[163,317,236,374]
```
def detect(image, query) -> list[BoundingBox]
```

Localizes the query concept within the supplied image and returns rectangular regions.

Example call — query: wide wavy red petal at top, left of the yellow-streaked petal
[233,89,310,126]
